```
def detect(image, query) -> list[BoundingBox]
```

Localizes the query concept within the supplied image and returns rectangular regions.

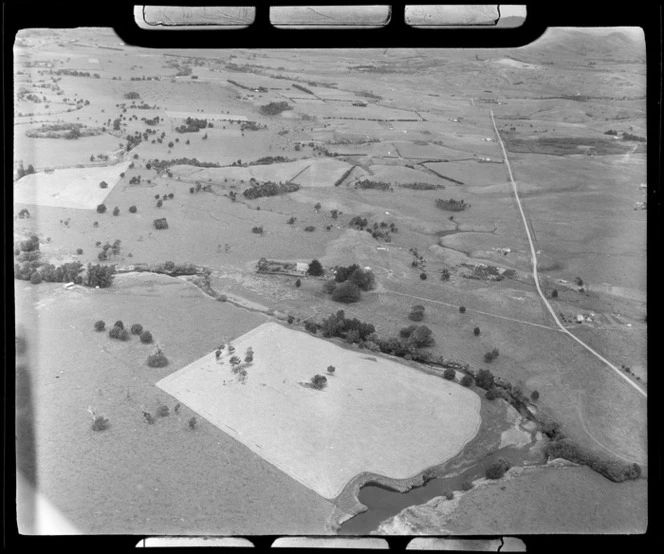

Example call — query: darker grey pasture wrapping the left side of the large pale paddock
[16,274,340,535]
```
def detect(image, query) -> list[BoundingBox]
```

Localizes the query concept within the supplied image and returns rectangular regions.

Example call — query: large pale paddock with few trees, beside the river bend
[157,323,480,499]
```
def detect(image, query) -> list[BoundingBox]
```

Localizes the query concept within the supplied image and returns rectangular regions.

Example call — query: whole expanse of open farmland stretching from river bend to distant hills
[12,25,648,535]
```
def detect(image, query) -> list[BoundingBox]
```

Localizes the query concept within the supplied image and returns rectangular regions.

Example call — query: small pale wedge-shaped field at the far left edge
[14,162,129,210]
